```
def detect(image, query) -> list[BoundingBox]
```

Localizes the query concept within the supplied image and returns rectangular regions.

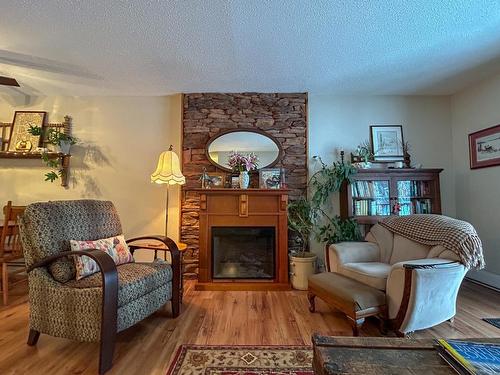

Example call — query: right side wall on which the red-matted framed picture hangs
[451,76,500,288]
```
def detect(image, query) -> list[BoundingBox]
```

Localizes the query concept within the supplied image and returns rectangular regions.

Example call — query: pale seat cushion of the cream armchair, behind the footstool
[339,262,391,290]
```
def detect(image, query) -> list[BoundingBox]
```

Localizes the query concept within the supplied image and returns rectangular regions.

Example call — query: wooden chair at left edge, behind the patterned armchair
[0,201,26,305]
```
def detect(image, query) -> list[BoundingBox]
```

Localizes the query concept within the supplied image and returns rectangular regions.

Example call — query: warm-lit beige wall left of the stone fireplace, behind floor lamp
[0,95,181,262]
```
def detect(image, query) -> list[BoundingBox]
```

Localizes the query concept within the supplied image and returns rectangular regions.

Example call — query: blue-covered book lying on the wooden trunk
[436,339,500,375]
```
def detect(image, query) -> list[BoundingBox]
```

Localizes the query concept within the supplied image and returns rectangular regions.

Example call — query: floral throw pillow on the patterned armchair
[70,235,134,280]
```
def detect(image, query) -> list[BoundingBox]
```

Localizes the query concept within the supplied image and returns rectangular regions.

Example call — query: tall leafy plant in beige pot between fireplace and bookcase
[288,157,360,290]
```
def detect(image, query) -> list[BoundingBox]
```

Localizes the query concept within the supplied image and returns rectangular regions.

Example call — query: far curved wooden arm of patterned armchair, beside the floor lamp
[126,235,182,318]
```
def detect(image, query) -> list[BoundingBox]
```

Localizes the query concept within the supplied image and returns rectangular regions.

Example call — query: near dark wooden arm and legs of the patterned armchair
[26,249,118,374]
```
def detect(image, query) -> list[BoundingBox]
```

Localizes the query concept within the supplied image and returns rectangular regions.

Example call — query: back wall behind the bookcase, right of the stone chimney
[309,95,455,253]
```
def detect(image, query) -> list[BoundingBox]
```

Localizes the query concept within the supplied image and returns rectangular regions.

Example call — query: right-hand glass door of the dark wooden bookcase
[396,180,432,216]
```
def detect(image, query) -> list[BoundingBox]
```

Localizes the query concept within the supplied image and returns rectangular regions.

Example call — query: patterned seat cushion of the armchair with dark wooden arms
[63,261,172,307]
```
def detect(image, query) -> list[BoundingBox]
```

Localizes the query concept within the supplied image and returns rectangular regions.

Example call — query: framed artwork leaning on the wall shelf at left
[7,111,47,152]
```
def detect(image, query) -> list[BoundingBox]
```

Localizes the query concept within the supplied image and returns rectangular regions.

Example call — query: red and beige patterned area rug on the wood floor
[167,345,314,375]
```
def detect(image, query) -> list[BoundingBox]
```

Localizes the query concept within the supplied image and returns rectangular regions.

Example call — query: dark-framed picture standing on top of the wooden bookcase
[370,125,404,163]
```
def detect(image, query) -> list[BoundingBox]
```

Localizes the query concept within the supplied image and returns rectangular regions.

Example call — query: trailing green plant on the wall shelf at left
[28,126,77,182]
